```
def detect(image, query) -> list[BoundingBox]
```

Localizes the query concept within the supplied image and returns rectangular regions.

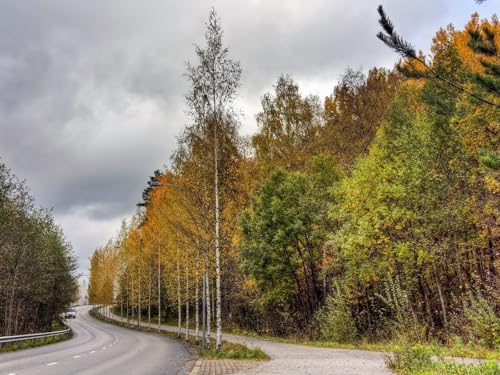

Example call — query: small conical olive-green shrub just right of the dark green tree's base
[316,285,357,343]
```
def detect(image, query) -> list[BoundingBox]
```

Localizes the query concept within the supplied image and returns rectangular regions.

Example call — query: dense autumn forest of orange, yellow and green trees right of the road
[90,8,500,348]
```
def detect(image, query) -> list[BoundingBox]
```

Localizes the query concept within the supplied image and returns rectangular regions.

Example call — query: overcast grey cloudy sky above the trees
[0,0,500,274]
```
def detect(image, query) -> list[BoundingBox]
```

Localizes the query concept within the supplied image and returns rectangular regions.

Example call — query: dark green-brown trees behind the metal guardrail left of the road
[0,163,78,336]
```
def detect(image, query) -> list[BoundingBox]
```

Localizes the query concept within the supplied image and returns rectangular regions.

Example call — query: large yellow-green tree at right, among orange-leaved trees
[332,40,491,332]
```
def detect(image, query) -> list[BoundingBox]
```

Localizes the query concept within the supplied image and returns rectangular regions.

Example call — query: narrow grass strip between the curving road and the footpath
[90,308,269,361]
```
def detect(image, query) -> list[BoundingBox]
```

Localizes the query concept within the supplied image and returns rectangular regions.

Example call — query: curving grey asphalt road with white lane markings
[0,306,192,375]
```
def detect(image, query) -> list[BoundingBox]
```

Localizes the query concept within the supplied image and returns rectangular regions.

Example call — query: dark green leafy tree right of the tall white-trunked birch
[240,157,340,333]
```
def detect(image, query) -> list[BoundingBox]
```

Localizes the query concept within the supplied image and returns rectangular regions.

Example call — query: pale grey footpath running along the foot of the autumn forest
[103,308,392,375]
